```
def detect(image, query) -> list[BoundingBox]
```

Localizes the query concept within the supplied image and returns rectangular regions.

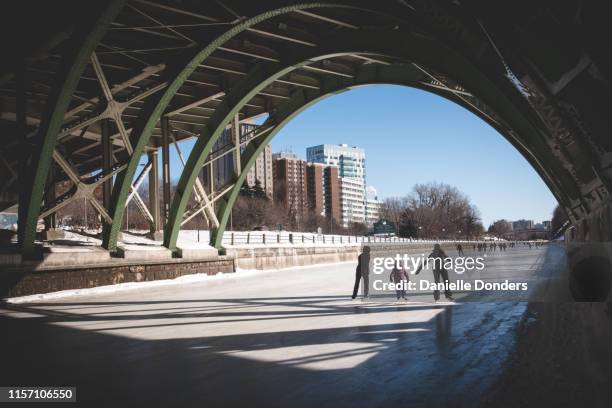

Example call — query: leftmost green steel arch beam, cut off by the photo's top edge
[19,0,126,256]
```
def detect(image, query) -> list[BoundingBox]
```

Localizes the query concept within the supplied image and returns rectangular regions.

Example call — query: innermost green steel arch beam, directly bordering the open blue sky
[211,65,563,248]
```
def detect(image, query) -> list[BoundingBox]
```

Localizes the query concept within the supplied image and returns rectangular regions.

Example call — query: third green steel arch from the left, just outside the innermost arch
[164,30,576,250]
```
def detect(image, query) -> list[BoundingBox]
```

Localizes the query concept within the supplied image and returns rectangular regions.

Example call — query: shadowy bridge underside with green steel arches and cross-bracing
[0,0,612,262]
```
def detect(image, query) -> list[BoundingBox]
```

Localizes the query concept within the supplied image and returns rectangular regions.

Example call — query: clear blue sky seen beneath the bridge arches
[169,85,557,227]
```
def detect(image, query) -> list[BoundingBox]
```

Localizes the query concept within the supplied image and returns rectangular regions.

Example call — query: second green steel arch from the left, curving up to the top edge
[102,0,384,252]
